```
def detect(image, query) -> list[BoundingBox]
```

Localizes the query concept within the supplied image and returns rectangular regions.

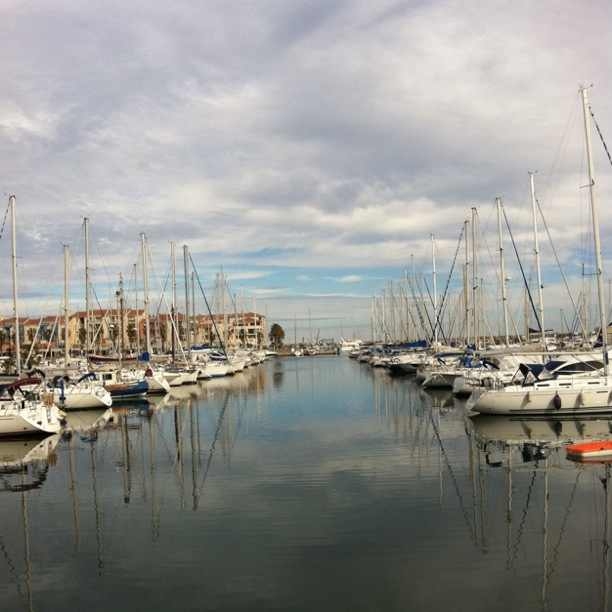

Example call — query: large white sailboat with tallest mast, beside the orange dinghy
[472,87,612,415]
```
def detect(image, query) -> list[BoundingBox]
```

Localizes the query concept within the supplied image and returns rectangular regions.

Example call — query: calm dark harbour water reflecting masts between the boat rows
[0,357,612,612]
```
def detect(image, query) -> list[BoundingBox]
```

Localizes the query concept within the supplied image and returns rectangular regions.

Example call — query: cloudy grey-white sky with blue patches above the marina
[0,0,612,337]
